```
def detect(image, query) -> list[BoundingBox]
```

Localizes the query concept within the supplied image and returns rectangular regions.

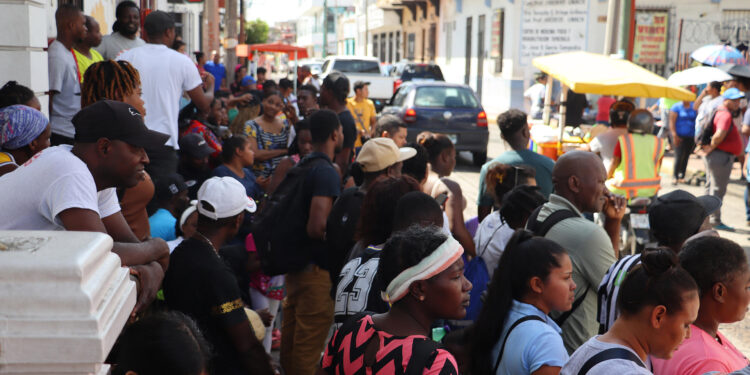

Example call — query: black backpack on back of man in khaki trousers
[252,156,330,276]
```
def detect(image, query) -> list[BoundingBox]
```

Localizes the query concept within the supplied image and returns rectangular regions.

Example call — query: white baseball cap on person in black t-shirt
[198,177,257,220]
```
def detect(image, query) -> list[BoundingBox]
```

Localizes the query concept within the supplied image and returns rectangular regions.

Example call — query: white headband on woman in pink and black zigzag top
[380,236,464,304]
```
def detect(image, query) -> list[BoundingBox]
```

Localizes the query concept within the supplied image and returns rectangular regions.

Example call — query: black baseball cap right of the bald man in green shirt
[648,190,721,238]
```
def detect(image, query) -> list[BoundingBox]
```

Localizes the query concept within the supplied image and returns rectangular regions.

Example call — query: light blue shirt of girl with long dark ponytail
[492,300,568,375]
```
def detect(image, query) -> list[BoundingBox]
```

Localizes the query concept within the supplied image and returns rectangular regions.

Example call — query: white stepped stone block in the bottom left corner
[0,231,136,374]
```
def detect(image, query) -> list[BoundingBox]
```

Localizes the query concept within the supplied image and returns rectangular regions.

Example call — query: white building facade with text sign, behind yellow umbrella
[436,0,607,114]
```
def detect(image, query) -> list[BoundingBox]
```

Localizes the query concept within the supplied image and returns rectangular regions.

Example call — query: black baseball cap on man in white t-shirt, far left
[72,100,169,149]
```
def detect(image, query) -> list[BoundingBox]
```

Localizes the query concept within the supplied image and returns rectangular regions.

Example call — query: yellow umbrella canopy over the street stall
[532,51,695,101]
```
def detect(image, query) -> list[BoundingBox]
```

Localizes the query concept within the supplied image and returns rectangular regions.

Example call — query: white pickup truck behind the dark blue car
[320,56,396,112]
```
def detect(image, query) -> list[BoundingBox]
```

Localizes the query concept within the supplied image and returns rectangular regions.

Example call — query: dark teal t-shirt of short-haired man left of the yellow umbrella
[477,150,555,206]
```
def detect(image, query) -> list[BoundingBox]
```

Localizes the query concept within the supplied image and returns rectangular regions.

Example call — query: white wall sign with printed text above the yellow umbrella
[519,0,589,66]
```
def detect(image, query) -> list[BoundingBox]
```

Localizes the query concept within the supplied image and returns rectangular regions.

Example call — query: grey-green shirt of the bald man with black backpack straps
[537,194,617,354]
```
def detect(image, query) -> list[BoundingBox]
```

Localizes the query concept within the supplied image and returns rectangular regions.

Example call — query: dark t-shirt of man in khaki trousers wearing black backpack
[302,152,341,270]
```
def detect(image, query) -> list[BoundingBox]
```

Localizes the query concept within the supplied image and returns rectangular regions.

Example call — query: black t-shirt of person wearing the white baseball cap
[163,238,249,374]
